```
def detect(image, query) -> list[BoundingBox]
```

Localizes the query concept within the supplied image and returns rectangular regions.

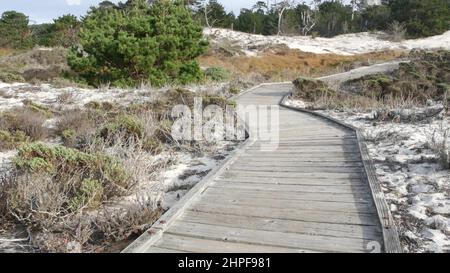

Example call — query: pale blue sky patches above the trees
[0,0,257,23]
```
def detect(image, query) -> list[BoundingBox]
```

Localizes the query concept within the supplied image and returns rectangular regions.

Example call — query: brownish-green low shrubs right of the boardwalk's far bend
[293,51,450,110]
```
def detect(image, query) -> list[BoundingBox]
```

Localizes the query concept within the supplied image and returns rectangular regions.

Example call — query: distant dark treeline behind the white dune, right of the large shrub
[188,0,450,38]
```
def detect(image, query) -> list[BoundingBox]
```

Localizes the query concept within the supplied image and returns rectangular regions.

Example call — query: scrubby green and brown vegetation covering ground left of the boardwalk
[0,83,239,252]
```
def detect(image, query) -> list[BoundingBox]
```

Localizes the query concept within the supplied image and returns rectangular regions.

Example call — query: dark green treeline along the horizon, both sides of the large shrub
[0,0,450,48]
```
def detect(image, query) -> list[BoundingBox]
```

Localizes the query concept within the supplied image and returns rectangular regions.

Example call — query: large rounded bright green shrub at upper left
[69,0,207,86]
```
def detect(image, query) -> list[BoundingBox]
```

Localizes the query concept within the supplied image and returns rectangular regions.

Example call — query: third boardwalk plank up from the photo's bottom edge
[180,211,382,241]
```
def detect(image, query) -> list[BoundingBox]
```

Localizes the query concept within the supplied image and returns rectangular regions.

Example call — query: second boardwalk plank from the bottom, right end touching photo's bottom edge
[167,221,369,252]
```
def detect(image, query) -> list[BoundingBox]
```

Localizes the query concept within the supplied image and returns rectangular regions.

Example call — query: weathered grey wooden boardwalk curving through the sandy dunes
[124,78,398,253]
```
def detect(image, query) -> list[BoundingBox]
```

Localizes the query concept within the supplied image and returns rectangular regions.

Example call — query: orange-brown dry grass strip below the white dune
[200,49,404,81]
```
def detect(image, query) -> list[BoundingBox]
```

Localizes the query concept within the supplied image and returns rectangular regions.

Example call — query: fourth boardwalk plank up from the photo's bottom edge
[189,202,379,226]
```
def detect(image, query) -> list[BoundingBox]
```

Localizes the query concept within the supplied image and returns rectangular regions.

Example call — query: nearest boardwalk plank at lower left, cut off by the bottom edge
[156,234,313,253]
